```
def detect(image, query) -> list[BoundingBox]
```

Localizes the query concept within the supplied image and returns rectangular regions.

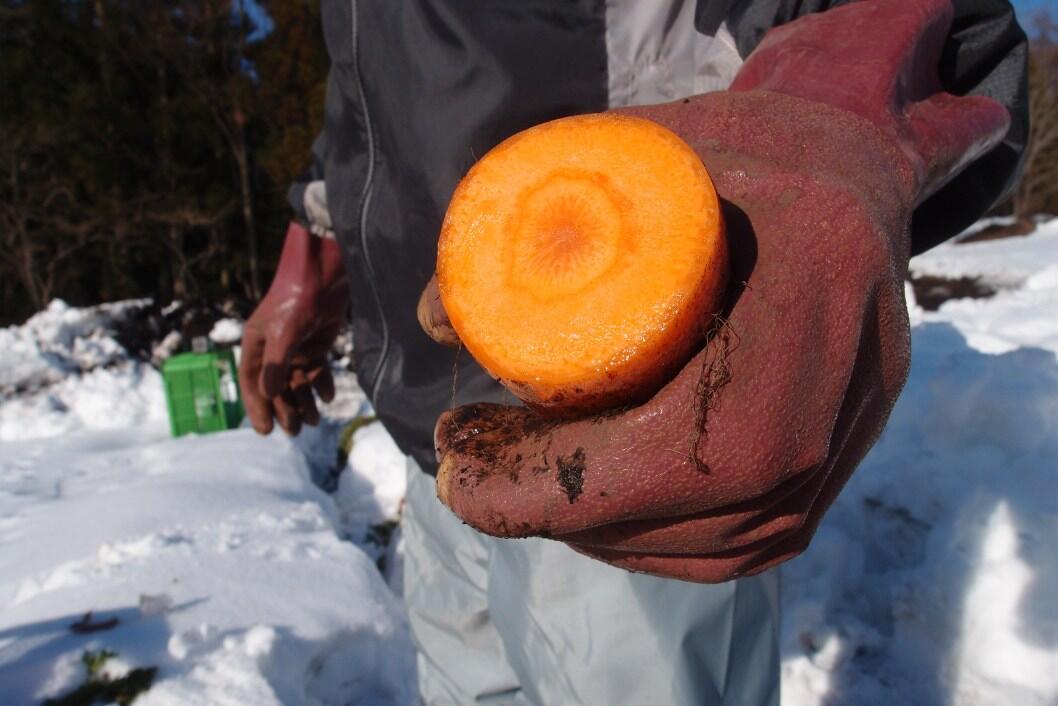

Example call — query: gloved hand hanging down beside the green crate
[239,222,349,435]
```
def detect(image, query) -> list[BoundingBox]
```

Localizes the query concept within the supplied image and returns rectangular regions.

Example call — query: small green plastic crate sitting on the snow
[162,350,243,436]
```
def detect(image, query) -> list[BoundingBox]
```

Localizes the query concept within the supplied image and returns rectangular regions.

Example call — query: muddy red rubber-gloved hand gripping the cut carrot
[420,0,1009,582]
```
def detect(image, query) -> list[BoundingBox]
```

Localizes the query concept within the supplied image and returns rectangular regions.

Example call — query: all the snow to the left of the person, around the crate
[0,302,416,706]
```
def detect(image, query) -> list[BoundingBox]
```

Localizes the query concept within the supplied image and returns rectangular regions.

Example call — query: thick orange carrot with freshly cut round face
[437,113,728,415]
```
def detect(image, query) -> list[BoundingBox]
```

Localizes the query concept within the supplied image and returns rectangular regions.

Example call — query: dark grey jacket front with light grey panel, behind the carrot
[324,0,742,469]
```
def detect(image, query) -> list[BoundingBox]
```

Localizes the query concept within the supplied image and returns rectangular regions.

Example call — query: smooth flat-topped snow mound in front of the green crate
[0,428,415,706]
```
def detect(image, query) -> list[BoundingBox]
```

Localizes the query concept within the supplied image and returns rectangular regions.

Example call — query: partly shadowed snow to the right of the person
[782,221,1058,706]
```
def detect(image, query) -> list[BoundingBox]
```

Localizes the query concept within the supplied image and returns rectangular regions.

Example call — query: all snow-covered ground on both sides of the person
[6,220,1058,706]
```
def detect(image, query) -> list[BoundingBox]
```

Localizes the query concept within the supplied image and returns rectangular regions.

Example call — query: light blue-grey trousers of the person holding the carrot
[403,460,779,706]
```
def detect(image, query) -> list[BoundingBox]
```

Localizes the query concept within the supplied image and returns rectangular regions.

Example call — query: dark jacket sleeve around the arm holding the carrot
[695,0,1028,254]
